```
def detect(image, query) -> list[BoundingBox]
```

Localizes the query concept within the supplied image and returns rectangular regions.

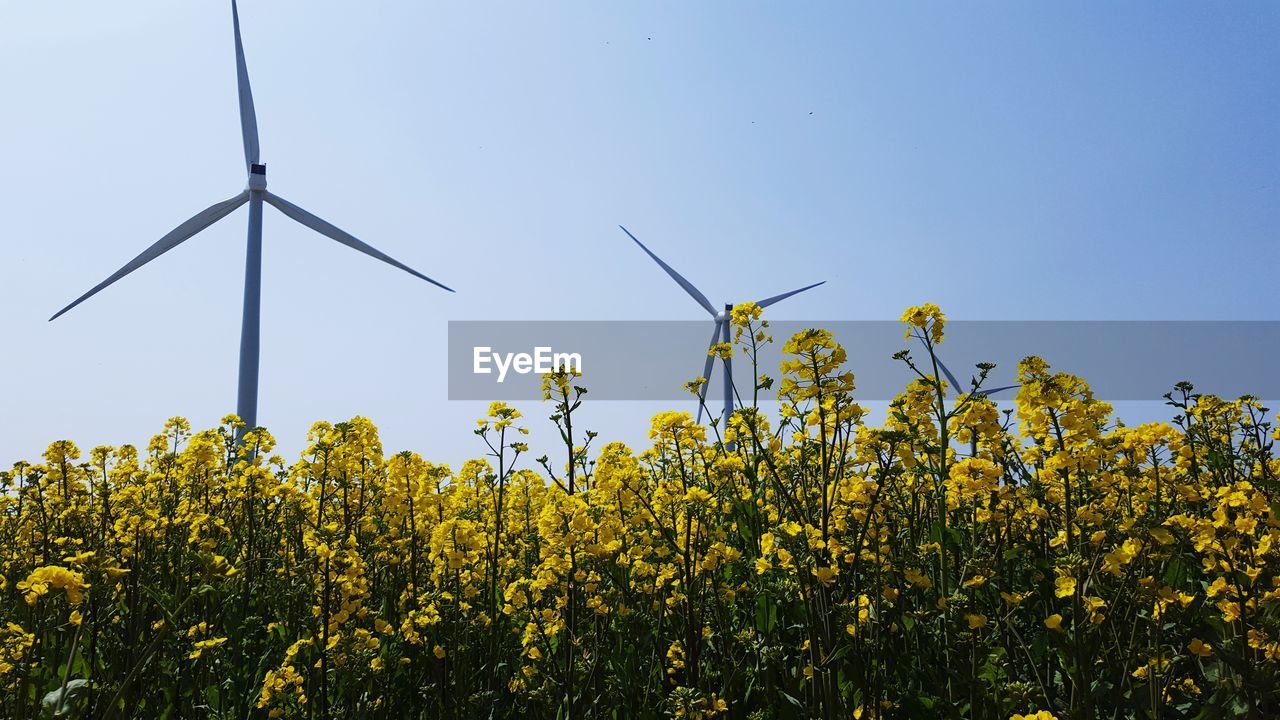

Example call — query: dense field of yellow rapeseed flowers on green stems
[0,305,1280,720]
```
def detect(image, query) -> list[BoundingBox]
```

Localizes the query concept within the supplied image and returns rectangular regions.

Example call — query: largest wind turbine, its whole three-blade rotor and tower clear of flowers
[49,0,453,428]
